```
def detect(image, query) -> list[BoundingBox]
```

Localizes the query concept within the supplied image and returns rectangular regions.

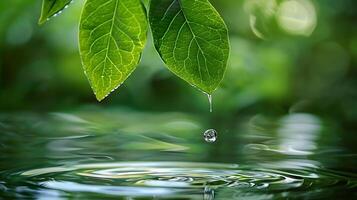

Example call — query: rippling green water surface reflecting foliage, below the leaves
[0,110,357,199]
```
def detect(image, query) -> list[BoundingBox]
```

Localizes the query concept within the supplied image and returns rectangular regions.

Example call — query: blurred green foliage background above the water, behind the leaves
[0,0,357,120]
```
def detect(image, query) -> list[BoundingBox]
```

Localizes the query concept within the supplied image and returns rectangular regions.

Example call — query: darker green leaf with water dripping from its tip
[149,0,229,94]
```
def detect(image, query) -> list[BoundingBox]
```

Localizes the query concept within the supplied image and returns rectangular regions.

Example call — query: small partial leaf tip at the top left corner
[38,0,73,24]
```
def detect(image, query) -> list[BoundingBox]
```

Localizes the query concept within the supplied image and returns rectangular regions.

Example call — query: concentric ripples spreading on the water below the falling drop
[16,162,356,199]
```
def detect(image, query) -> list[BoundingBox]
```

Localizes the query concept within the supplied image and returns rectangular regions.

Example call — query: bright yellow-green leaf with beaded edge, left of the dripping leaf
[79,0,148,101]
